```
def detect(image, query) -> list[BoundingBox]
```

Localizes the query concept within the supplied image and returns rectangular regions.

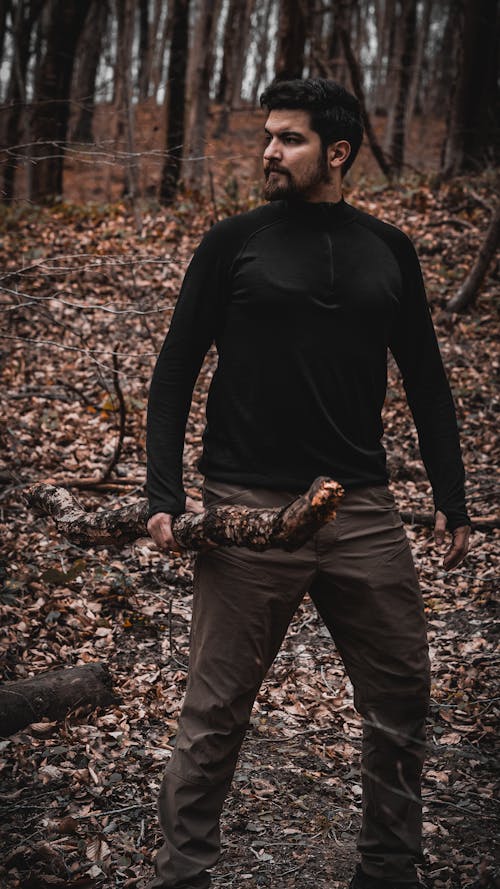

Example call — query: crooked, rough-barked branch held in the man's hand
[24,478,344,552]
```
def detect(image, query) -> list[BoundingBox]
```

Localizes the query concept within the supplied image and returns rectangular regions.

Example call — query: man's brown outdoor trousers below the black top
[150,481,429,889]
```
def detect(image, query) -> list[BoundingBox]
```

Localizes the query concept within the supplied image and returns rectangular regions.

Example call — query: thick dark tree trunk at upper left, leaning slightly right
[30,0,91,201]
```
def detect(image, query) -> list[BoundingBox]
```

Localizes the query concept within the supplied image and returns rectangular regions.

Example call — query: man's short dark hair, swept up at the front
[260,77,363,176]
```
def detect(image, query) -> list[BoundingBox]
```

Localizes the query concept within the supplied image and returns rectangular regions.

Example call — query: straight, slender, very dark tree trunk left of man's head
[159,0,189,205]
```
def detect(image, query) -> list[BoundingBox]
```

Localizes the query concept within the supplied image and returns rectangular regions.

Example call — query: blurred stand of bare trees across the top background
[0,0,499,203]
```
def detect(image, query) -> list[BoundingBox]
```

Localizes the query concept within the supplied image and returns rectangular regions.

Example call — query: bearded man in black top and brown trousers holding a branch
[148,79,469,889]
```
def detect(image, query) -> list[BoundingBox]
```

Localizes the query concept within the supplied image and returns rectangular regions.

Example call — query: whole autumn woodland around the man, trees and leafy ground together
[0,0,500,889]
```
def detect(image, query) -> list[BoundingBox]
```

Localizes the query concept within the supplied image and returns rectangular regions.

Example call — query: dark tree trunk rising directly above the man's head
[276,0,310,80]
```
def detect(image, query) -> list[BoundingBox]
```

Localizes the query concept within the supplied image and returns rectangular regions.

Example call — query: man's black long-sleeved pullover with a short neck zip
[147,201,468,529]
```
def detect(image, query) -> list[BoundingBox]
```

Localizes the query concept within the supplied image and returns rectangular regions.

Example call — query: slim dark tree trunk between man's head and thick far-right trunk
[389,0,417,175]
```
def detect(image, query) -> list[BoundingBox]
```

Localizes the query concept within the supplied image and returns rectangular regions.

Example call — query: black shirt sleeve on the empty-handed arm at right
[390,236,470,530]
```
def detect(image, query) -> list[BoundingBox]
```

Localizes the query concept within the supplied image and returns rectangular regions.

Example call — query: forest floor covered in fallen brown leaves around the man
[0,137,500,889]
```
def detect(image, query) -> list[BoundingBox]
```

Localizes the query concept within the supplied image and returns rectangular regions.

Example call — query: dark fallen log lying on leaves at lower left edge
[0,664,117,738]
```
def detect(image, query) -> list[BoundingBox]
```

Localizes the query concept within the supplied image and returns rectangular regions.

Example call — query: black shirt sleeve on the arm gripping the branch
[146,226,226,518]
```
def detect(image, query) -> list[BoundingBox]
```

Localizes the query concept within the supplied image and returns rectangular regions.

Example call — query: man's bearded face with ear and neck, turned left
[264,109,330,201]
